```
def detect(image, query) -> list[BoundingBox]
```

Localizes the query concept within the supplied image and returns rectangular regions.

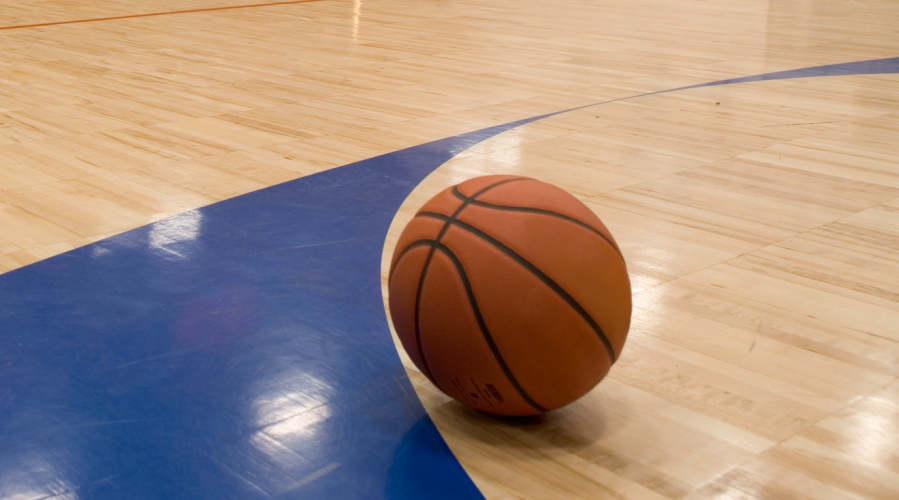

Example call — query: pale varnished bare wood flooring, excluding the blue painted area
[0,0,899,500]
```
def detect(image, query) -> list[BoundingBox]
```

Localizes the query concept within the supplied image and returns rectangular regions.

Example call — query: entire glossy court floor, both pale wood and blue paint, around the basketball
[0,0,899,500]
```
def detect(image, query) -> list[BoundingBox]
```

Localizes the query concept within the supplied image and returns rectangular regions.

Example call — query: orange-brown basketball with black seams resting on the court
[389,175,631,415]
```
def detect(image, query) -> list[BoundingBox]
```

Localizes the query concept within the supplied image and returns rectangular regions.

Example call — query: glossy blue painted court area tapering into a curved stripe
[0,59,899,500]
